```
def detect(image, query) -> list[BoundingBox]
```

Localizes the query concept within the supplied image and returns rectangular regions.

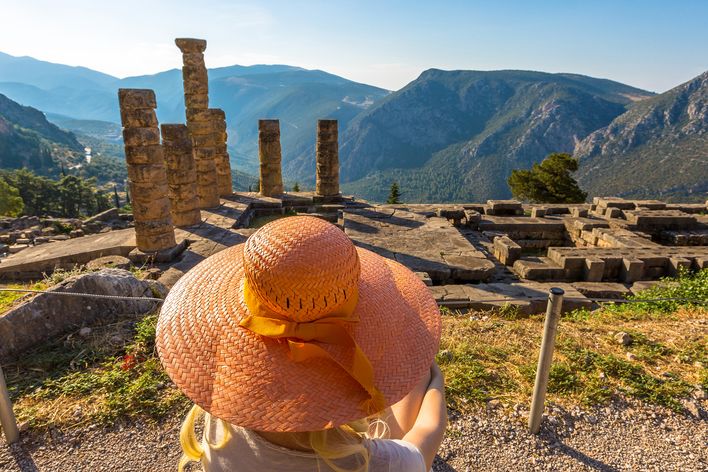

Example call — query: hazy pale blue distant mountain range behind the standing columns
[0,53,389,175]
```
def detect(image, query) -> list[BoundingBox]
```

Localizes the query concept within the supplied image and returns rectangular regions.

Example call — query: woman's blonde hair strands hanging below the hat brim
[179,405,389,472]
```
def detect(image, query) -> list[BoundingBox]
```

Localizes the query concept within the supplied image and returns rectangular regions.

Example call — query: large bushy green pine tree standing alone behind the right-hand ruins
[507,153,587,203]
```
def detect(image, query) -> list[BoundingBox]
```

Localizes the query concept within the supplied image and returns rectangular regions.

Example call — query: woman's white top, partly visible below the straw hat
[202,415,426,472]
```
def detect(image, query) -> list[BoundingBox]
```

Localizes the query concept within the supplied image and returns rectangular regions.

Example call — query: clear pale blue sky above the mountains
[0,0,708,92]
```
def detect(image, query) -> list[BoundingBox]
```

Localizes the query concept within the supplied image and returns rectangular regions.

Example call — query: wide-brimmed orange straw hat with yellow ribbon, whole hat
[157,216,440,431]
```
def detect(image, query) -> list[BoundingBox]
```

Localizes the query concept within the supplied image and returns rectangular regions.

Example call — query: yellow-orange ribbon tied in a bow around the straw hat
[239,278,386,415]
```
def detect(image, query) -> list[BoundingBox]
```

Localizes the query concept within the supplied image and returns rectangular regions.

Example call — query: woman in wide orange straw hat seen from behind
[157,217,447,472]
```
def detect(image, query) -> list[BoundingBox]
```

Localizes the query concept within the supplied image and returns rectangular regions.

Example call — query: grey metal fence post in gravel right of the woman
[529,287,565,434]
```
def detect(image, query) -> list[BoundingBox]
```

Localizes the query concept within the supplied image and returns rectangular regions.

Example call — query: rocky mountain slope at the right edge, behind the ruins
[575,71,708,201]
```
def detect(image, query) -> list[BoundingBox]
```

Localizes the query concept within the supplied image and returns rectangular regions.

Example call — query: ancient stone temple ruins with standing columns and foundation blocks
[0,39,708,313]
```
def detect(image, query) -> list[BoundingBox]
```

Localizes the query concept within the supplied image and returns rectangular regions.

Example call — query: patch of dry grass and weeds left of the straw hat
[3,315,188,429]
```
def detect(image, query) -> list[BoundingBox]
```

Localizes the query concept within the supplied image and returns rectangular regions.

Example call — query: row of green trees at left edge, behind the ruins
[0,169,113,218]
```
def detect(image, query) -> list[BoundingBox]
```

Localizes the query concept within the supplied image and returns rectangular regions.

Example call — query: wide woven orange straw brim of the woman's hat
[156,244,440,431]
